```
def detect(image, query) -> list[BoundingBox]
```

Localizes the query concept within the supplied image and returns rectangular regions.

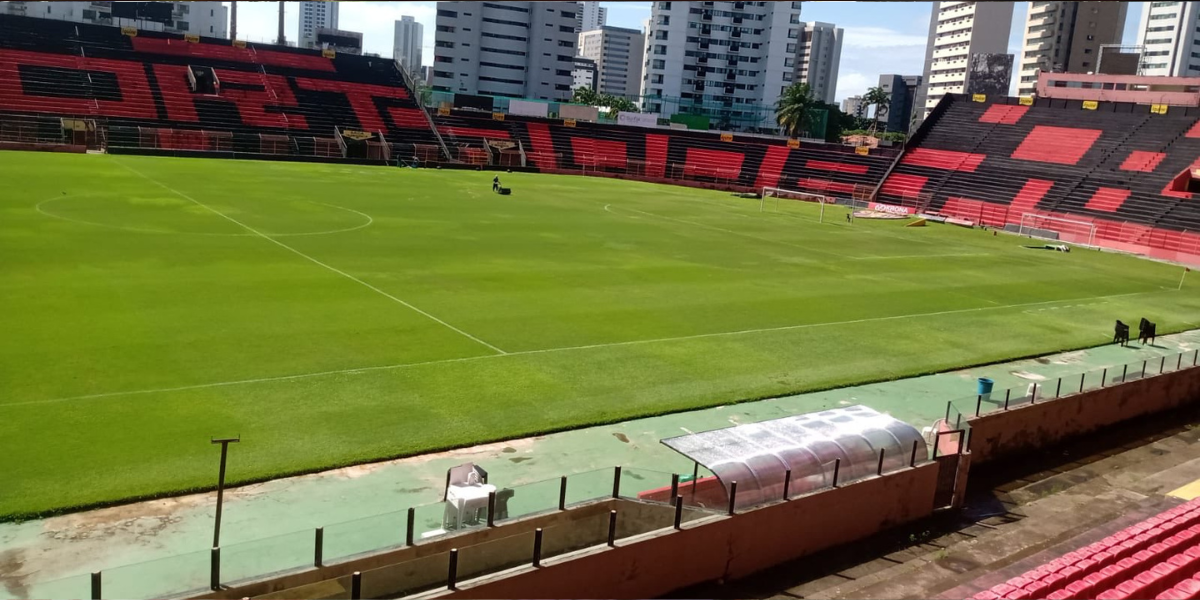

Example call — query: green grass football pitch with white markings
[0,152,1200,518]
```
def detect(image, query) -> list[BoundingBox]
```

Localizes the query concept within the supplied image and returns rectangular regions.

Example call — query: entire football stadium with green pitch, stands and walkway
[0,2,1200,599]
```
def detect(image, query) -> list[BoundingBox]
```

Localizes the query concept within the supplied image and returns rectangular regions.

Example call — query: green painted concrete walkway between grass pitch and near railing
[0,330,1200,599]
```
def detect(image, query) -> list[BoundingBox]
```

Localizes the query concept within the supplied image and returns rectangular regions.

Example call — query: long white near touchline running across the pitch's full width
[0,290,1174,410]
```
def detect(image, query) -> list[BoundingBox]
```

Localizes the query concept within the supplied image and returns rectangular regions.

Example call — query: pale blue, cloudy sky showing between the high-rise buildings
[231,1,1144,101]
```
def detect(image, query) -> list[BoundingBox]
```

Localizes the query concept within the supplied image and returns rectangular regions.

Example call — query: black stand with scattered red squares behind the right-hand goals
[877,96,1200,258]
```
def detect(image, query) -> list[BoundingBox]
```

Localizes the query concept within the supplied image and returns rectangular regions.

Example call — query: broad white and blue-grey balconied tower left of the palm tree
[642,1,804,130]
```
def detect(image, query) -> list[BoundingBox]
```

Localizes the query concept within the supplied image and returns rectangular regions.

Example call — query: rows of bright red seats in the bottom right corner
[974,500,1200,600]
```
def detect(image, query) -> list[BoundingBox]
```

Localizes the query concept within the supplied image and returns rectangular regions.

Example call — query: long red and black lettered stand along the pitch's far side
[0,16,896,198]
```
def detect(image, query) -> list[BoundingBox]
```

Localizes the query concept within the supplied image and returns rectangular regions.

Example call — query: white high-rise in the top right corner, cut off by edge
[1138,2,1200,77]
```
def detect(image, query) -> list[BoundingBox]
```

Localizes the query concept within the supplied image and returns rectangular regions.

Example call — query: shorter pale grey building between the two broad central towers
[578,25,646,100]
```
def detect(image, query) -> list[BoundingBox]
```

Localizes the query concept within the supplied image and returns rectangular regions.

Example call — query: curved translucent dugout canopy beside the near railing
[662,404,929,508]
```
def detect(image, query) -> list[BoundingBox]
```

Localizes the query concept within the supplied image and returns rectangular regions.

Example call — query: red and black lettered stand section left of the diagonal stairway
[0,16,434,154]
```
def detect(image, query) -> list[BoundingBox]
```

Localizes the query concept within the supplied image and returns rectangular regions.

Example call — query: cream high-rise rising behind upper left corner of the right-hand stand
[917,2,1013,121]
